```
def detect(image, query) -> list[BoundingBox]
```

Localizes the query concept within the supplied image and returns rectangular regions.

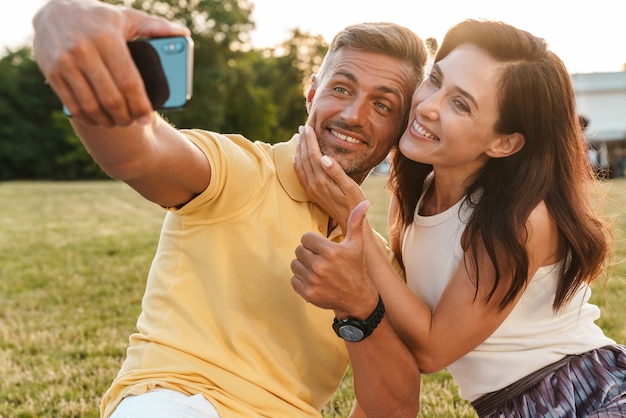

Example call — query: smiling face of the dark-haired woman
[399,44,503,173]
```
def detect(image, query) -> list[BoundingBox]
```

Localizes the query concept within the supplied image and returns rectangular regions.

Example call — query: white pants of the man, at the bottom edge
[111,389,220,418]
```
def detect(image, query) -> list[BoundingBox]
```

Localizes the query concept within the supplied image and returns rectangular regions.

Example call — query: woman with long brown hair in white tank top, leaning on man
[292,20,626,417]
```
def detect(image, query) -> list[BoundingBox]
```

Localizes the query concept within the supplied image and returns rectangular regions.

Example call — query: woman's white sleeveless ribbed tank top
[402,178,615,401]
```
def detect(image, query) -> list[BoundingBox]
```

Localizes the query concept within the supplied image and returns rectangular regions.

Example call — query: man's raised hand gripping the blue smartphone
[33,0,190,127]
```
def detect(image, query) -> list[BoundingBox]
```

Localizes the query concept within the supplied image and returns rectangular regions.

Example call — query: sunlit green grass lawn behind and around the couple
[0,176,626,418]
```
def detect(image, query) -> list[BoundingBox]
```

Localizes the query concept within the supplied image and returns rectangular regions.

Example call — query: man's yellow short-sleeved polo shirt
[102,130,349,418]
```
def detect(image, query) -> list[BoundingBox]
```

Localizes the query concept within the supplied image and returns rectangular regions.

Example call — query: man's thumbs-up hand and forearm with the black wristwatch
[291,201,420,418]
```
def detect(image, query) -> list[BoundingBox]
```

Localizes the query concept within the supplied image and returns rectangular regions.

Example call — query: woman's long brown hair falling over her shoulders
[389,20,611,311]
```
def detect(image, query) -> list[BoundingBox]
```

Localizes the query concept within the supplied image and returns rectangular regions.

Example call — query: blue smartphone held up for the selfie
[63,36,193,116]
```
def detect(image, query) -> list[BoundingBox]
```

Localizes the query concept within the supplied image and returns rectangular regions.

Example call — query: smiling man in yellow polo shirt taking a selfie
[33,0,427,418]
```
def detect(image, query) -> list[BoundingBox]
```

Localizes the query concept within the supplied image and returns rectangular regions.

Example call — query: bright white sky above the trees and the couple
[0,0,626,73]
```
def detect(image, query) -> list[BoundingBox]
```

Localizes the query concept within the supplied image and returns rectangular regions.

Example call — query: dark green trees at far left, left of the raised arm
[0,46,103,180]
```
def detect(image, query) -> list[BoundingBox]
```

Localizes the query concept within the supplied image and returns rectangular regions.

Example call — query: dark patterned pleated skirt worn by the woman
[472,345,626,418]
